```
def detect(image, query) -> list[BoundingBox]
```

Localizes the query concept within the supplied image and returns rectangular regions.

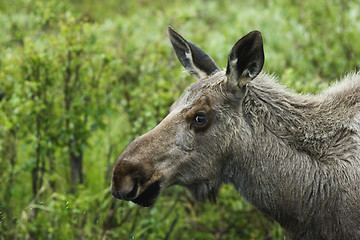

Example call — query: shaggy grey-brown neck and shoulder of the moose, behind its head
[219,74,360,239]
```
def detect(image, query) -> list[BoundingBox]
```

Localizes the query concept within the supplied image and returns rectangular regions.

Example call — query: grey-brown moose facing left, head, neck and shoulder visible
[110,27,360,240]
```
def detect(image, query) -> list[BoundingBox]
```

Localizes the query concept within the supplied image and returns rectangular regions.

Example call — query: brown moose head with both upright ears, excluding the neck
[111,27,264,207]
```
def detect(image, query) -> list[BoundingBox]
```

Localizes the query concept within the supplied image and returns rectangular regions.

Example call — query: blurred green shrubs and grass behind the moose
[0,0,360,240]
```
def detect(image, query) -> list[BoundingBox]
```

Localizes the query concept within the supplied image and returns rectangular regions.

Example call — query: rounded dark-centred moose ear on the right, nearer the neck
[226,31,265,88]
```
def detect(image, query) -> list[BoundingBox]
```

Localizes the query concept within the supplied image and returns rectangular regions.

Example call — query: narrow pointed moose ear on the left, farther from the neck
[168,27,220,79]
